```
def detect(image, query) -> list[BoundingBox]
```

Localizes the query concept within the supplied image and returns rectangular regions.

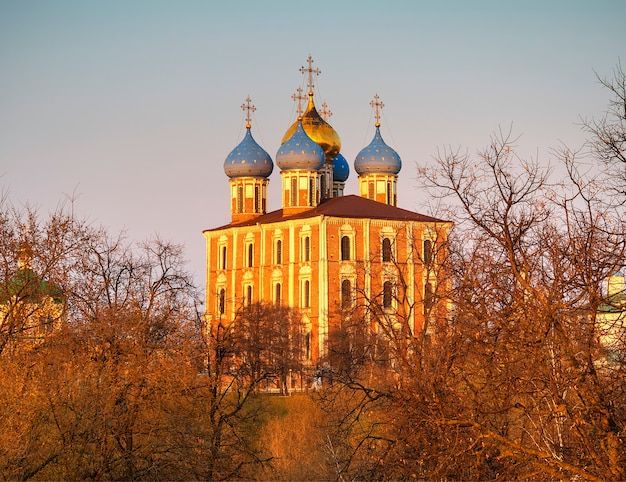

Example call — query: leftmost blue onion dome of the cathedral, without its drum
[224,124,274,178]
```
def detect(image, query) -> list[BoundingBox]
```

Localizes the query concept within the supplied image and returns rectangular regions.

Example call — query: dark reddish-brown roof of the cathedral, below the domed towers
[205,194,450,231]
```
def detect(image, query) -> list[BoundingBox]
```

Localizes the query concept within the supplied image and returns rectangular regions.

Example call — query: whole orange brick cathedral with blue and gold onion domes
[203,56,452,366]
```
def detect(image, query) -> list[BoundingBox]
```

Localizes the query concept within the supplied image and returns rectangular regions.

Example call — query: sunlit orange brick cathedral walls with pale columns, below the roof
[205,217,443,361]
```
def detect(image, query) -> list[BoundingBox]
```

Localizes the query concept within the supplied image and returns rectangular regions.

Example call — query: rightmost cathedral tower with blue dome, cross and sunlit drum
[354,94,402,206]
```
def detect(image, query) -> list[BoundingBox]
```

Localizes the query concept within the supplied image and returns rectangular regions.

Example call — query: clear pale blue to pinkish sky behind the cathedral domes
[0,0,626,287]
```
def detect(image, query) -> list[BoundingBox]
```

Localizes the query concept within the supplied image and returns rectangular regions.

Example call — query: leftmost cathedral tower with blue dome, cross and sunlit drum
[224,97,274,223]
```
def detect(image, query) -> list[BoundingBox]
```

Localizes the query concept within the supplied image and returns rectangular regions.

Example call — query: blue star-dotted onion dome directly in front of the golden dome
[276,118,326,171]
